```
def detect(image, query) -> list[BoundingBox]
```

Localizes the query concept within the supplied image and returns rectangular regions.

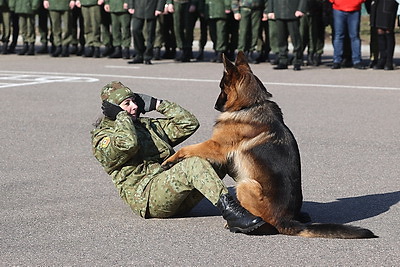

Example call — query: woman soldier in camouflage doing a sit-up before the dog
[92,82,265,233]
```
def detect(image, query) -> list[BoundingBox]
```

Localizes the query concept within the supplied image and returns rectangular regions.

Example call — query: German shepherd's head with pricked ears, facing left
[215,51,272,112]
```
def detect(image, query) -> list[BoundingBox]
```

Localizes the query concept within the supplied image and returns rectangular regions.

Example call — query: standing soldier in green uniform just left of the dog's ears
[200,0,231,62]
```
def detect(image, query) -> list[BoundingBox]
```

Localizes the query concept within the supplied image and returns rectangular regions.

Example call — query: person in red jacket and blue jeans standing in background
[329,0,365,69]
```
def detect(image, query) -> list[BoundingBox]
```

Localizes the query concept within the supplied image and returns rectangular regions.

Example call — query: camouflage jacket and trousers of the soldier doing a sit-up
[91,100,227,217]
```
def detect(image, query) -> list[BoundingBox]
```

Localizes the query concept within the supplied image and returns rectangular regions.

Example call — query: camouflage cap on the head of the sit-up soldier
[101,81,135,105]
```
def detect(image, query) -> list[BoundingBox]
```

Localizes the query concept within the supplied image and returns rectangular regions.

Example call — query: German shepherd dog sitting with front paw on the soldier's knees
[163,52,376,238]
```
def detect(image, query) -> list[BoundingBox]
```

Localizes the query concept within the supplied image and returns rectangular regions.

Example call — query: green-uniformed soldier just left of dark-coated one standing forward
[105,0,131,59]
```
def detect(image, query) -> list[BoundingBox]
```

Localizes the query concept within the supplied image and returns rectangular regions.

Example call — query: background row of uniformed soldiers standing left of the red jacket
[0,0,395,69]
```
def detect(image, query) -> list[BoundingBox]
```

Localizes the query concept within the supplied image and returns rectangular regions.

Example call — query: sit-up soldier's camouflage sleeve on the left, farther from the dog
[92,112,139,174]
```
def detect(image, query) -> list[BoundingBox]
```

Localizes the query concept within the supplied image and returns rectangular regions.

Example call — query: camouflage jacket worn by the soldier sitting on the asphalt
[91,100,199,217]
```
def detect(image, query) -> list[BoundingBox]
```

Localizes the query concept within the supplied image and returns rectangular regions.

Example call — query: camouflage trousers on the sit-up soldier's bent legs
[146,157,228,218]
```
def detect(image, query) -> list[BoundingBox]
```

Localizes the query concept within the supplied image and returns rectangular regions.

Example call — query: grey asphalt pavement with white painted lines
[0,51,400,266]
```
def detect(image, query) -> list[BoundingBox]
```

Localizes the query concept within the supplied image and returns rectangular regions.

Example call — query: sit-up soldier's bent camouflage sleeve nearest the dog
[157,100,200,146]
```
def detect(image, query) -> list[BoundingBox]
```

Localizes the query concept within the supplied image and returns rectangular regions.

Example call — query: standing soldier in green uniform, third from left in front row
[48,0,72,57]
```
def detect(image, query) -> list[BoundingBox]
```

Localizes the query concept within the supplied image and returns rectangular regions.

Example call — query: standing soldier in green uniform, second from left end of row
[9,0,41,55]
